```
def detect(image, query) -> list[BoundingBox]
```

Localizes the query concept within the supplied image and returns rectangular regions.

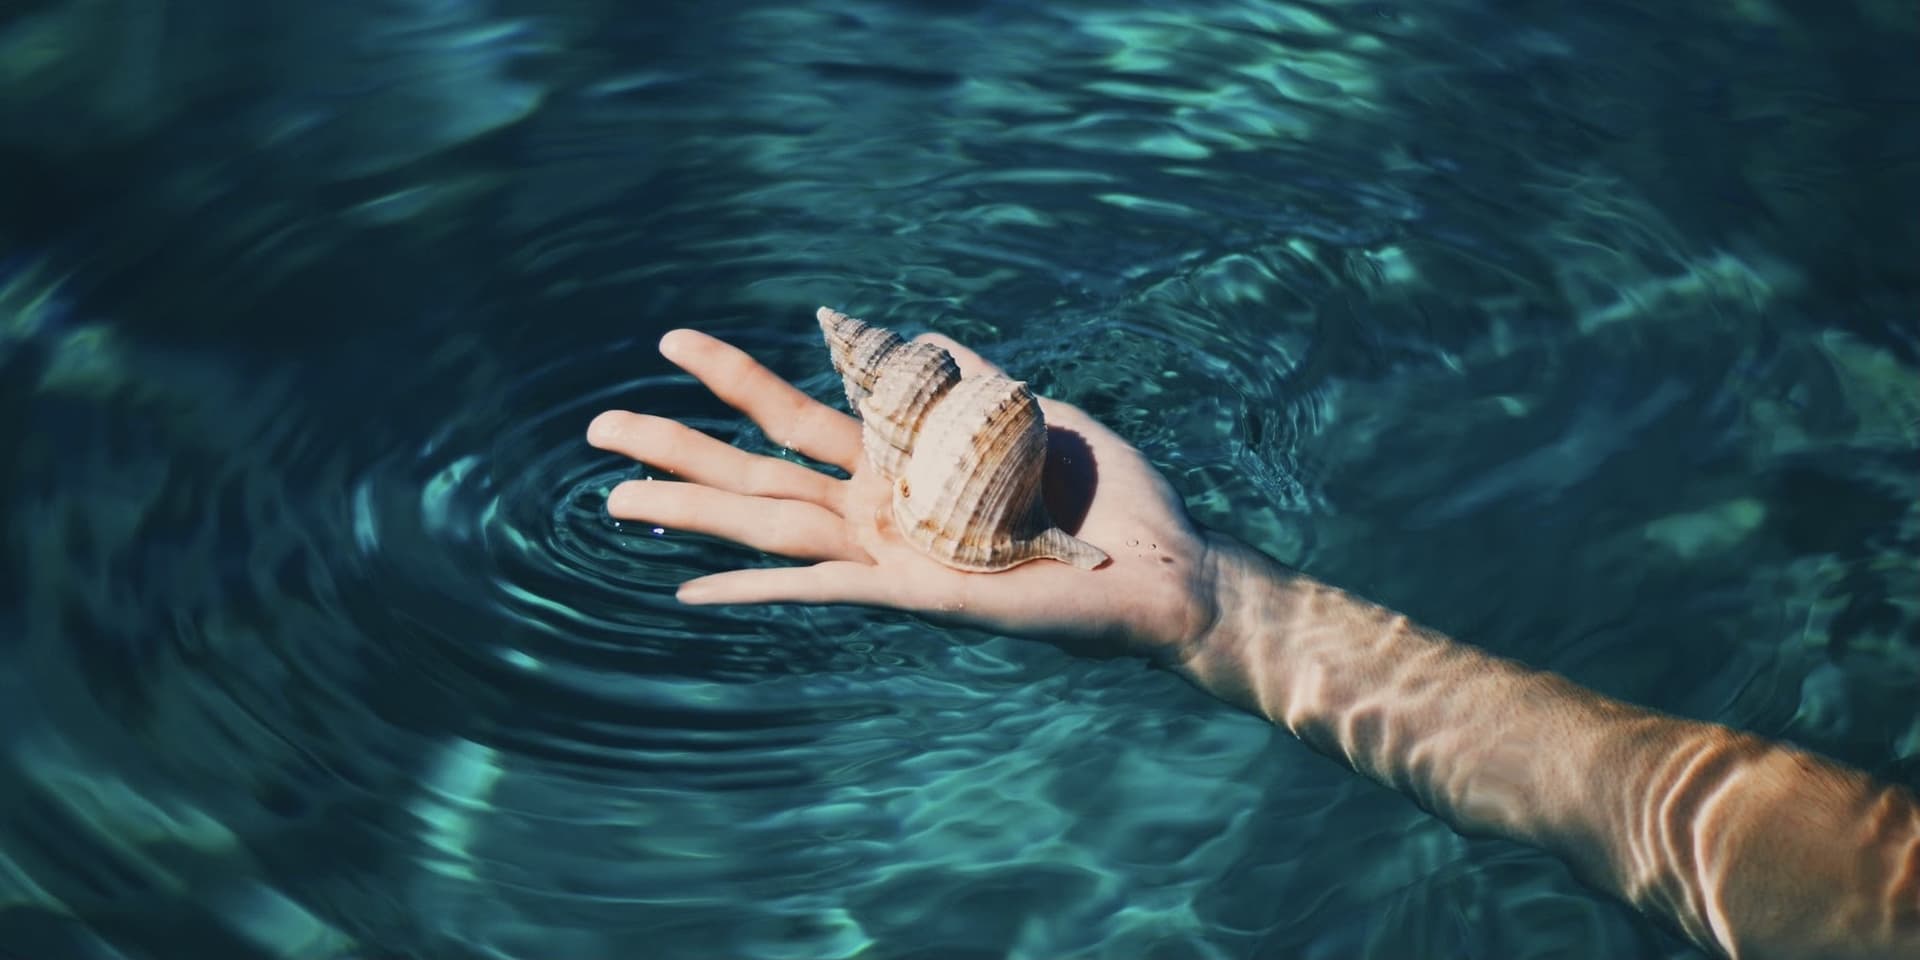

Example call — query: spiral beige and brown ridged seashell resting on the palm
[818,307,1106,572]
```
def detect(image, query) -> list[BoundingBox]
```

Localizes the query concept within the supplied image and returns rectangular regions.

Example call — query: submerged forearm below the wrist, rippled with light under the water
[1179,543,1920,958]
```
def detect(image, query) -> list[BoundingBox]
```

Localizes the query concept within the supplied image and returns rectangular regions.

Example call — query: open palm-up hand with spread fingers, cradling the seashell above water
[588,330,1215,660]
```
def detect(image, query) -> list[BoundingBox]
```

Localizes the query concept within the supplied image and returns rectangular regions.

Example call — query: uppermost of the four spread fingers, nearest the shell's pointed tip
[660,330,860,472]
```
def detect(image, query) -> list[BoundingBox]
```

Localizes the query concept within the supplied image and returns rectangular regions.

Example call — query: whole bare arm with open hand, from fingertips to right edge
[588,330,1920,960]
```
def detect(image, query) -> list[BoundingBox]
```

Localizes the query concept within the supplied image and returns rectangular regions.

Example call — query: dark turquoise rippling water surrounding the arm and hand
[0,0,1920,960]
